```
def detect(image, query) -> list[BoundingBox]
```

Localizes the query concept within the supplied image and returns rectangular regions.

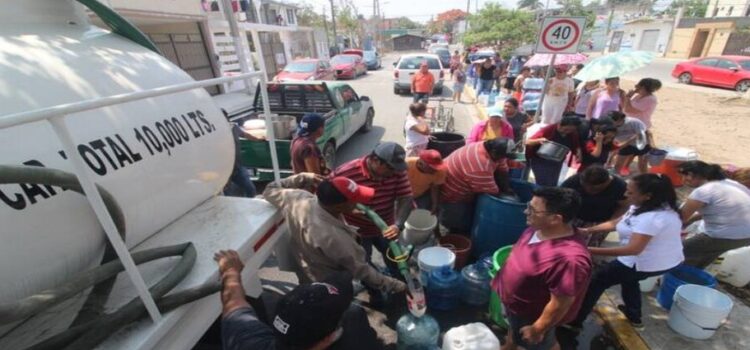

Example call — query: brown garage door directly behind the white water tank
[141,23,220,95]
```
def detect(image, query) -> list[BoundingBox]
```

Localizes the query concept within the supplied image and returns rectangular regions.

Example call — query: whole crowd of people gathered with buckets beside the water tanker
[216,49,750,349]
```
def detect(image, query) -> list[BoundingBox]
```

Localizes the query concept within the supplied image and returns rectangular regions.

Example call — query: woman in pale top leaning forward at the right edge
[677,160,750,268]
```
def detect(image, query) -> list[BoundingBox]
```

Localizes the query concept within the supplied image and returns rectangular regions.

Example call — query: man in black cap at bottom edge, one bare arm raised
[214,250,382,350]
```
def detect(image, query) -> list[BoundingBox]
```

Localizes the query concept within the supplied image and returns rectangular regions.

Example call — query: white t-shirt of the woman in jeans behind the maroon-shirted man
[617,206,685,272]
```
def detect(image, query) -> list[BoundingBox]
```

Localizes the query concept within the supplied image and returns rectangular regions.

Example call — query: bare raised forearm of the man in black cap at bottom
[214,250,250,316]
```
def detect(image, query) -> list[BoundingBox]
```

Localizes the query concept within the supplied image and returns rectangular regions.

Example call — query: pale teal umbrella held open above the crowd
[575,51,656,81]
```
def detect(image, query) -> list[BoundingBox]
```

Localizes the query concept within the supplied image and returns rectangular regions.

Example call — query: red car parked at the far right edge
[672,56,750,92]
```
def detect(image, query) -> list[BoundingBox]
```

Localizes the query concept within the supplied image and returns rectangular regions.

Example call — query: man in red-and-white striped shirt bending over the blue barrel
[440,137,515,235]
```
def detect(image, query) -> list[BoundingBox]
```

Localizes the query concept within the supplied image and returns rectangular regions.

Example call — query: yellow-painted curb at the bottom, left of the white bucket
[594,293,651,350]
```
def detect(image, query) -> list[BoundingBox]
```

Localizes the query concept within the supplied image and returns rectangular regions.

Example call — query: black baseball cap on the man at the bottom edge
[272,272,354,350]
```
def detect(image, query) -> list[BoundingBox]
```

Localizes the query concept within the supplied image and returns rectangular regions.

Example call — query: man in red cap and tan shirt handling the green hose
[263,173,406,293]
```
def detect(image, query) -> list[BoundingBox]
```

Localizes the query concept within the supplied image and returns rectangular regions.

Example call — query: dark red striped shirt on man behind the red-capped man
[331,156,412,238]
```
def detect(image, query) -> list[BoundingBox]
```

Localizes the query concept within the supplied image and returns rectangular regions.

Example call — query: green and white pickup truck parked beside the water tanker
[240,81,375,181]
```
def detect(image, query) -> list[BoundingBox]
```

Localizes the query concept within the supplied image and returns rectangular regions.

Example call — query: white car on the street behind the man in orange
[393,54,445,95]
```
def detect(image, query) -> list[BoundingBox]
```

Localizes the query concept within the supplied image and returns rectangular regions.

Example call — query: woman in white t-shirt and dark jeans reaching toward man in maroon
[569,174,683,329]
